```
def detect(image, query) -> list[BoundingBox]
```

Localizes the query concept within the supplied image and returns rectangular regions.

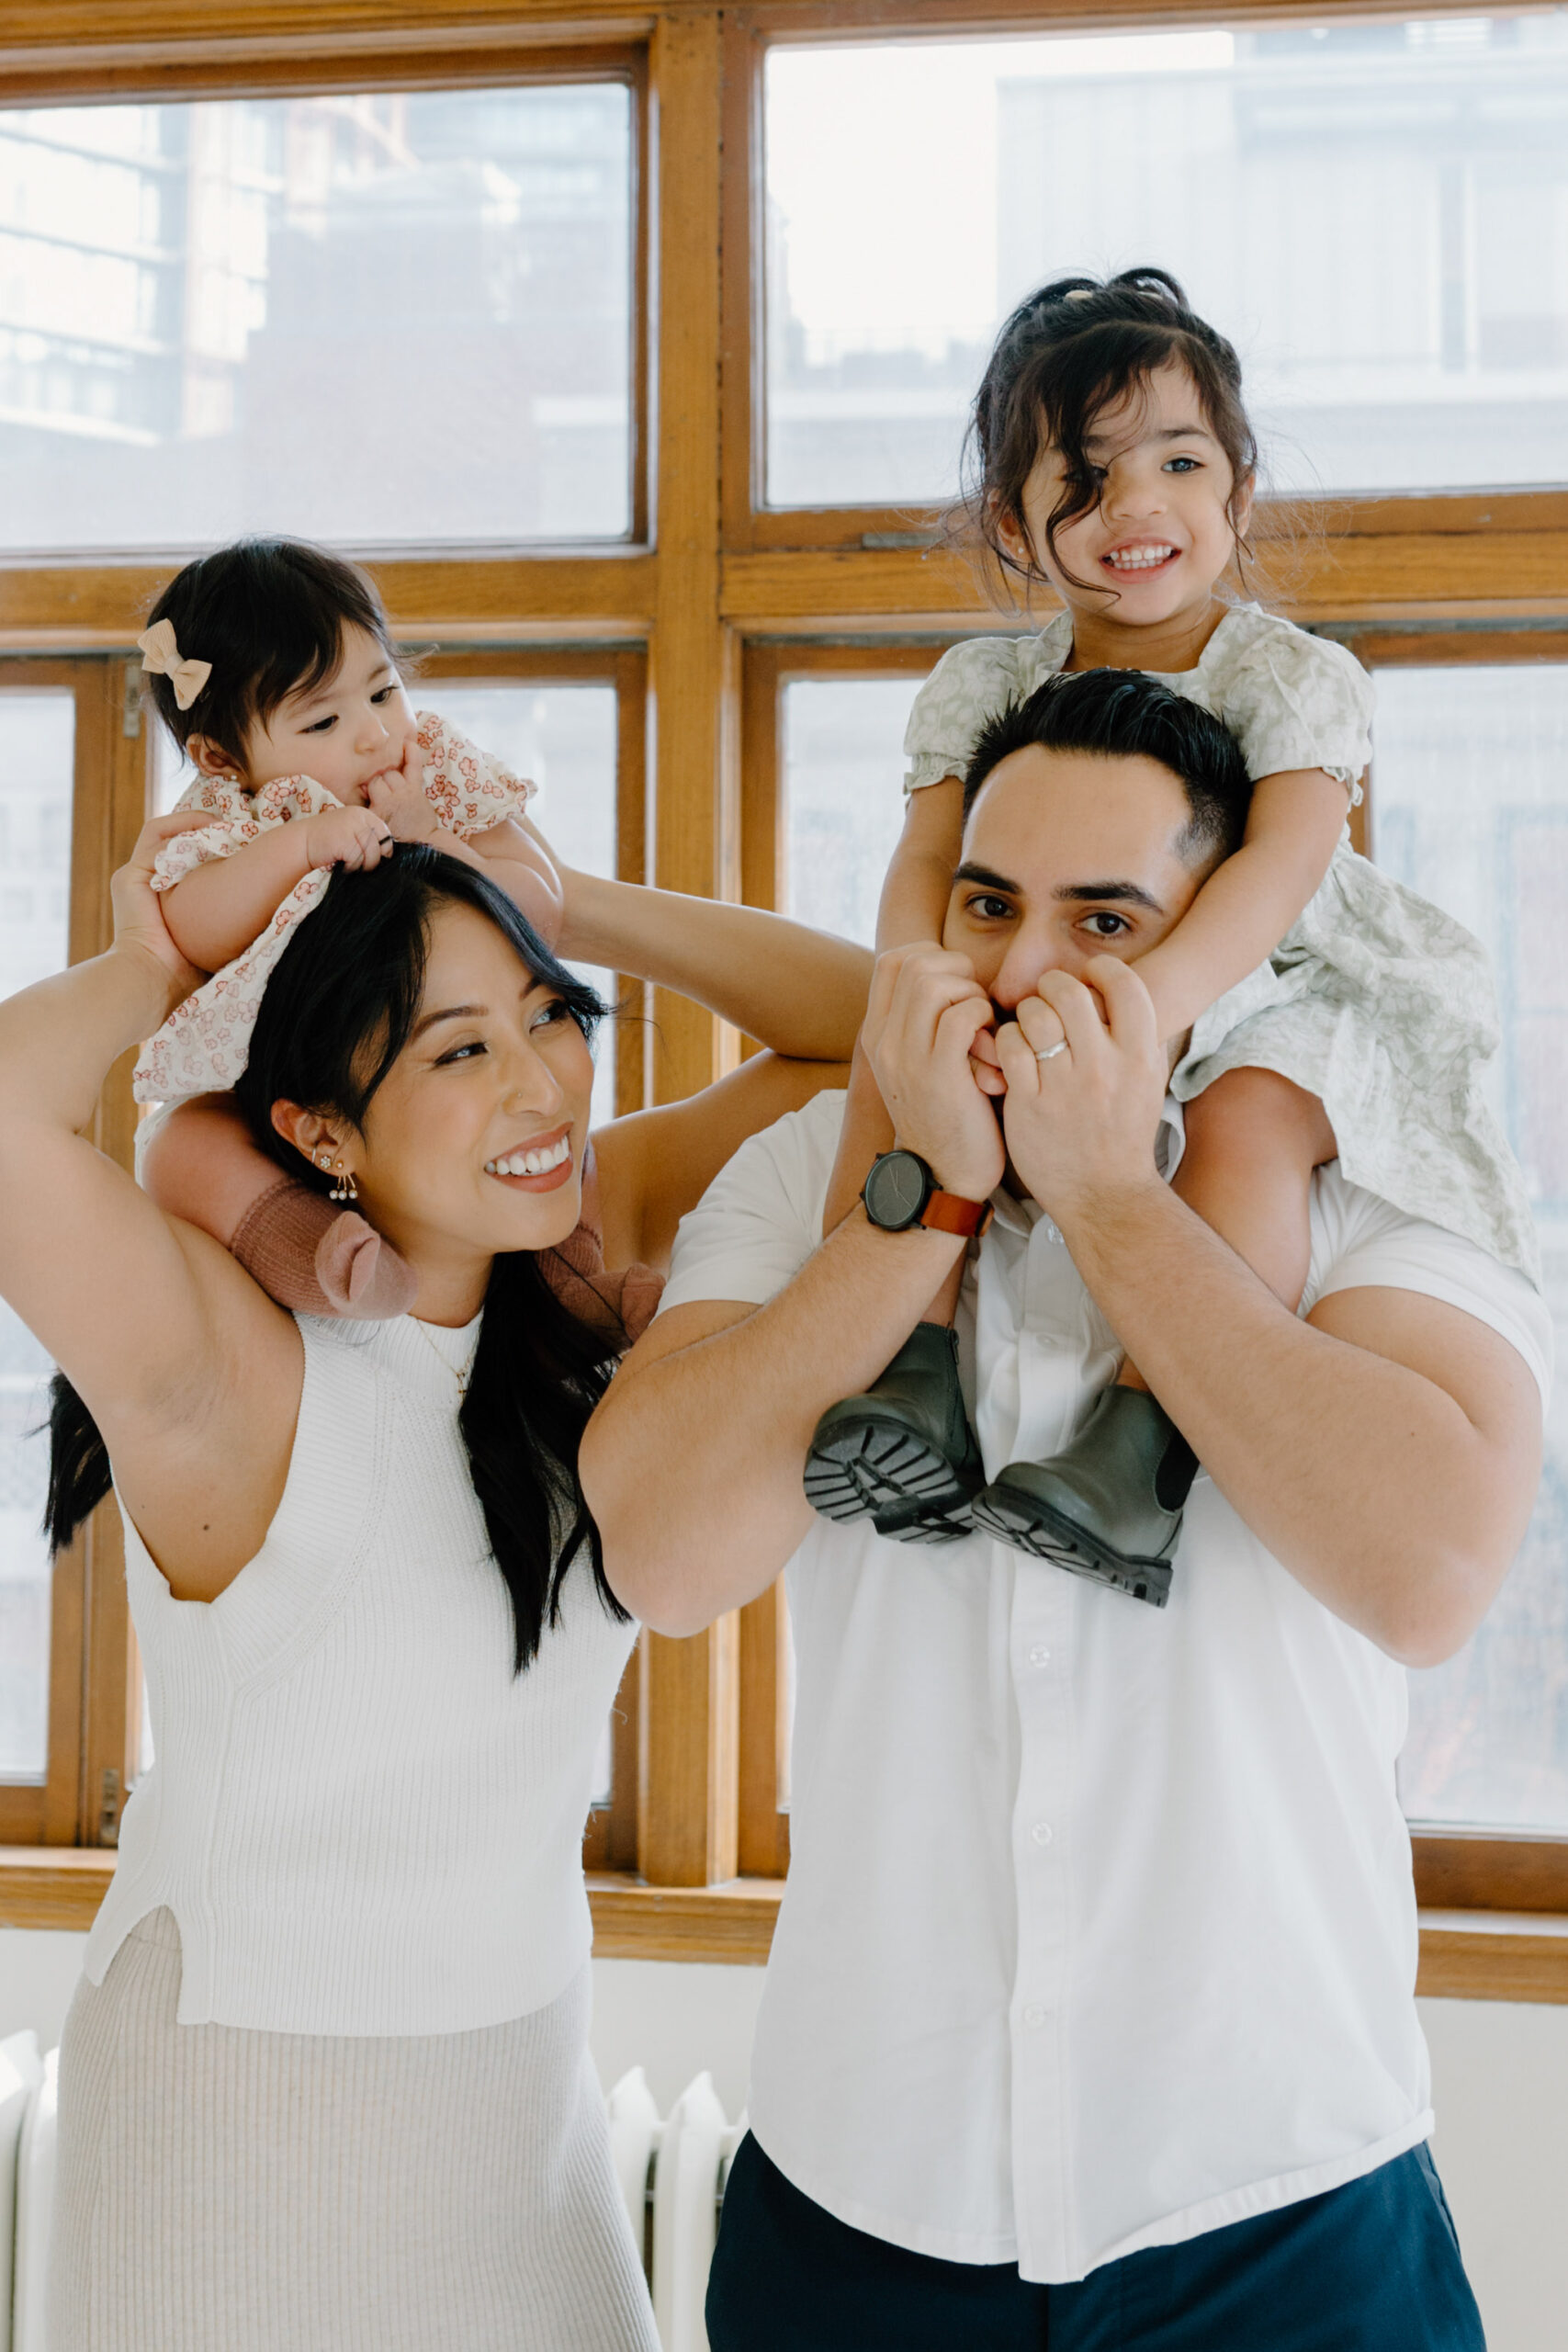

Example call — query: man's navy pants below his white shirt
[707,2133,1485,2352]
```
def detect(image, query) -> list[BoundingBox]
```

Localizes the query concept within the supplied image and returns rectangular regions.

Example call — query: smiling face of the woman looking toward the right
[344,903,592,1272]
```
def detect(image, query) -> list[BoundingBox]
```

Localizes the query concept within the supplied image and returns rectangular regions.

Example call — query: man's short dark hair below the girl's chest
[964,671,1253,865]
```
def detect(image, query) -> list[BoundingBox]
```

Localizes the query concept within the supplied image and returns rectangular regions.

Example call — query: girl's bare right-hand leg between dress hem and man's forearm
[1119,1070,1340,1387]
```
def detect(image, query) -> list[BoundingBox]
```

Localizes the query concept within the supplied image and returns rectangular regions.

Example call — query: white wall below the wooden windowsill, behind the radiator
[0,1928,1568,2352]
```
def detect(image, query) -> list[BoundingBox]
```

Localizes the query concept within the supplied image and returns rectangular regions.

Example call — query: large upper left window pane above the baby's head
[0,83,632,550]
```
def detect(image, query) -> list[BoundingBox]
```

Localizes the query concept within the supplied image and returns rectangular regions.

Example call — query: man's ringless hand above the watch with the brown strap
[861,944,1006,1200]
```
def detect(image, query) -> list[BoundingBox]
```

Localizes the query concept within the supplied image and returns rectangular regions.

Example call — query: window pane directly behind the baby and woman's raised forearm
[409,677,616,1122]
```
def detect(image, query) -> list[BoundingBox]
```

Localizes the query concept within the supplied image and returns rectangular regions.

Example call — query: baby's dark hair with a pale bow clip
[148,538,398,772]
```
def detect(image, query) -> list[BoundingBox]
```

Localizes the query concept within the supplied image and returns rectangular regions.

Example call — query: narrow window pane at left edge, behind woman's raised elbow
[0,687,75,1781]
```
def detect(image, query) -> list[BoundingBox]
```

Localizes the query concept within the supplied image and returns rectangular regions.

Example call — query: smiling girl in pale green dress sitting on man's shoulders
[807,270,1535,1601]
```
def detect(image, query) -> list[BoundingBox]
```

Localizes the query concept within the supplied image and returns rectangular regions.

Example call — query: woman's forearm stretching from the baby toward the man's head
[559,868,872,1061]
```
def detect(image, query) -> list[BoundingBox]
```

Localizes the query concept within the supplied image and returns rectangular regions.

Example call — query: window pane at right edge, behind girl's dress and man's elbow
[1373,665,1568,1835]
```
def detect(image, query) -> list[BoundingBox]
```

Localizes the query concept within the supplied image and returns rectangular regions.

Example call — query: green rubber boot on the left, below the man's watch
[807,1324,985,1543]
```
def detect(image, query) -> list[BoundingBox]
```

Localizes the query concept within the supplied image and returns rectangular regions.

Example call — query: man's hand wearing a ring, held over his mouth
[997,955,1166,1230]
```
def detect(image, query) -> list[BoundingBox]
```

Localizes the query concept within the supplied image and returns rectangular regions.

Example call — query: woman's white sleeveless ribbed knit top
[87,1315,632,2034]
